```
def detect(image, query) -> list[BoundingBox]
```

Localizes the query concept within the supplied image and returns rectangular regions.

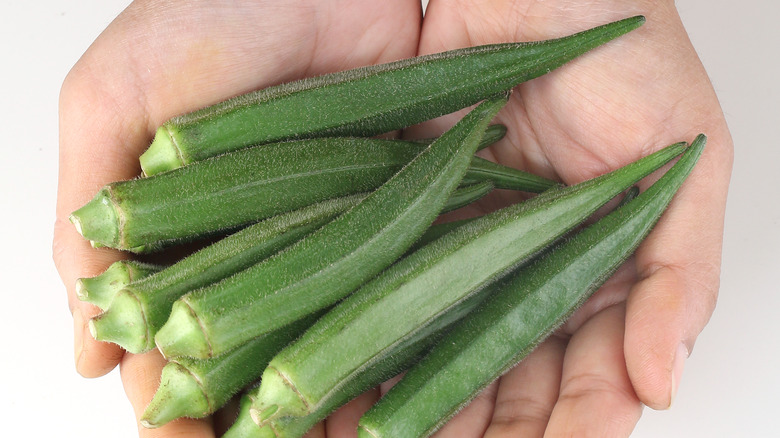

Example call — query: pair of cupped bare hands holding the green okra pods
[53,0,733,438]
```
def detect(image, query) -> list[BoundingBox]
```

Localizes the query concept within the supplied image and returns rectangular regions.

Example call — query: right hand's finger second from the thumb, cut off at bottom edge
[485,337,566,438]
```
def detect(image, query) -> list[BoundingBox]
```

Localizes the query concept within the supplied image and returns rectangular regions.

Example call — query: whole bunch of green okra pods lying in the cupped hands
[71,17,705,437]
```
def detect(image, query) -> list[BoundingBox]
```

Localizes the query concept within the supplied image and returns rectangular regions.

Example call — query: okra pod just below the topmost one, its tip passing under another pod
[71,134,557,252]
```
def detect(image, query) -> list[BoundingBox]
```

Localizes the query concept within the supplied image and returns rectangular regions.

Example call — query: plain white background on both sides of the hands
[0,0,780,438]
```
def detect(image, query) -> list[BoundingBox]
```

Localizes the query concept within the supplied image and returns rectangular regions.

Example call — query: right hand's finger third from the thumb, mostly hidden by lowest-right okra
[433,382,498,438]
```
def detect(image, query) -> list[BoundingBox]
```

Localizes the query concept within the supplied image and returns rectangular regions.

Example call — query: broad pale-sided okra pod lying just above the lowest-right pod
[242,144,684,421]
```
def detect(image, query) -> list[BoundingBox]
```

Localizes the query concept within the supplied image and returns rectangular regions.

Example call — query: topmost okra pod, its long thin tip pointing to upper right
[140,16,645,175]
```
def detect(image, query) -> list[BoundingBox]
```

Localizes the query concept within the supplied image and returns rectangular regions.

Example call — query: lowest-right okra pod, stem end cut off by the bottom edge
[359,135,706,438]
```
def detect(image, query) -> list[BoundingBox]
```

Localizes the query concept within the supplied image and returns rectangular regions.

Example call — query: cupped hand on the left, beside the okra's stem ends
[53,0,422,438]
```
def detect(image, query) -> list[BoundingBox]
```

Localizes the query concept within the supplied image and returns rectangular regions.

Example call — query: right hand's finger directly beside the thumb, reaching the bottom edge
[545,305,642,437]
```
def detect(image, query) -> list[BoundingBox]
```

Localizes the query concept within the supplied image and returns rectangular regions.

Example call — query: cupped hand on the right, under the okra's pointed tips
[402,0,733,437]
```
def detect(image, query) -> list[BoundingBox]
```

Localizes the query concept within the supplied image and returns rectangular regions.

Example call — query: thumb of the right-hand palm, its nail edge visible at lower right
[625,133,731,409]
